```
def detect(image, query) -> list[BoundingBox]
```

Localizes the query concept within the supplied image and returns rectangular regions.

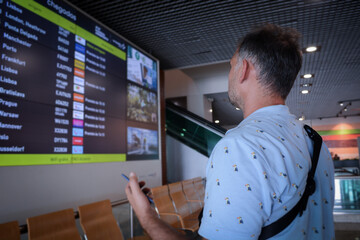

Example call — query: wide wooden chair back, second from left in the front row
[27,208,81,240]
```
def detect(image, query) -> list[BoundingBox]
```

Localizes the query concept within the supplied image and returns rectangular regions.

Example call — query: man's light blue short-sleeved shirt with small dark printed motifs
[199,105,335,240]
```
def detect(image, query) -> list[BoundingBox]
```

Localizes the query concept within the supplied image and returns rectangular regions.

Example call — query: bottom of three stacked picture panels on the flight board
[127,127,159,160]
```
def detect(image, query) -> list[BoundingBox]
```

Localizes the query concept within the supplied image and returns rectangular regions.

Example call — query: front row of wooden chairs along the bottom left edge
[0,200,150,240]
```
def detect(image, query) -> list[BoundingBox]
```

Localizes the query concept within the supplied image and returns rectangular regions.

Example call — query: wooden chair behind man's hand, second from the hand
[169,182,202,220]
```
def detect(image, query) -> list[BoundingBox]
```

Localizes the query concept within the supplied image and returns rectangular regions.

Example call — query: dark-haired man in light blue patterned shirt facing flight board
[126,24,334,240]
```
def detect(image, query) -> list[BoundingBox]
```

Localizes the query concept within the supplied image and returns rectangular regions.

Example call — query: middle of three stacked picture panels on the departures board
[127,84,157,123]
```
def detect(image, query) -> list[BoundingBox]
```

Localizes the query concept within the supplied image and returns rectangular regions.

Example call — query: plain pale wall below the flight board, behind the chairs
[0,160,161,224]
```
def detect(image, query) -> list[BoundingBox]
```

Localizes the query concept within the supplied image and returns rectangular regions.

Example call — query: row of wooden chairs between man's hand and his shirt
[151,177,205,232]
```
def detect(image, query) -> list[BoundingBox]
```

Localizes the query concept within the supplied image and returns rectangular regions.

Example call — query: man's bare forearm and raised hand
[125,173,187,240]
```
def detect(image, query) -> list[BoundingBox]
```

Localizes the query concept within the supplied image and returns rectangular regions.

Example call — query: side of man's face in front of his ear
[228,52,242,108]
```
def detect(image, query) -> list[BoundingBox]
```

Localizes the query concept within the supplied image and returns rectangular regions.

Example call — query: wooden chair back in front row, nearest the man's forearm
[78,199,123,240]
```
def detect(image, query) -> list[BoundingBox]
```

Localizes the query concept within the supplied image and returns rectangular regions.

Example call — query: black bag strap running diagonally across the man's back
[259,125,322,240]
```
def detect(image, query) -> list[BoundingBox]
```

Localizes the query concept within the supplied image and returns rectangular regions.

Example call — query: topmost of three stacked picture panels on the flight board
[127,46,157,90]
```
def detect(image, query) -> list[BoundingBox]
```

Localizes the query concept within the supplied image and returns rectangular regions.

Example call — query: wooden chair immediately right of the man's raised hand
[151,185,199,232]
